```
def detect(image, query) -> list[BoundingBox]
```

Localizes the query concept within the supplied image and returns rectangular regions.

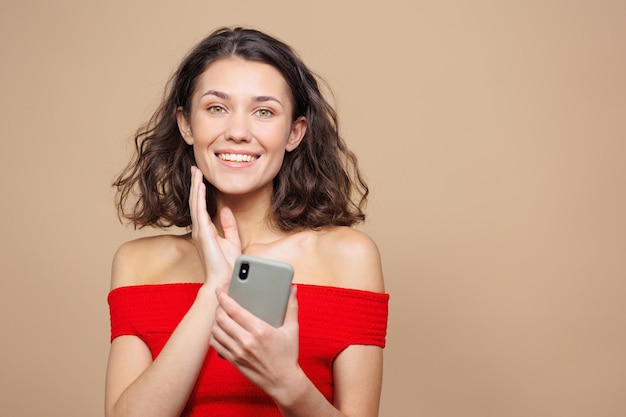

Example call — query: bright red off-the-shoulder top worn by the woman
[108,283,389,417]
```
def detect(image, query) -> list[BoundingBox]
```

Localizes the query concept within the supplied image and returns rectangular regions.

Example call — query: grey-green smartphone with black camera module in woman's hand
[228,255,293,327]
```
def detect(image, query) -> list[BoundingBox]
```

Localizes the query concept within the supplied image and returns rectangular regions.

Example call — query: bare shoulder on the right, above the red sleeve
[318,227,385,292]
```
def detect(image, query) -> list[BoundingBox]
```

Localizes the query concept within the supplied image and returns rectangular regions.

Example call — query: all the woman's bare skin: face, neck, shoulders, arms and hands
[105,58,384,417]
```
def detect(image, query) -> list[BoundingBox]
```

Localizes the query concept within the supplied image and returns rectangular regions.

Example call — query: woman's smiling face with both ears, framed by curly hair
[177,58,306,195]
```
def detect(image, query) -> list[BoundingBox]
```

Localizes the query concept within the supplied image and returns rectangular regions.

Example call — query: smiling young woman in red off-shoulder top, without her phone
[105,28,388,417]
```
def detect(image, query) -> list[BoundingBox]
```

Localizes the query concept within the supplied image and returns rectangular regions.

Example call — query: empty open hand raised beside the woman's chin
[189,167,241,289]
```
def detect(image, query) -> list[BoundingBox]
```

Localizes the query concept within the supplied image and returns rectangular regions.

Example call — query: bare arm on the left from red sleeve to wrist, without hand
[105,286,222,417]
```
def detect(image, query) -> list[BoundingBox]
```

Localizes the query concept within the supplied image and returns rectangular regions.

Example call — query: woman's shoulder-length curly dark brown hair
[113,27,369,231]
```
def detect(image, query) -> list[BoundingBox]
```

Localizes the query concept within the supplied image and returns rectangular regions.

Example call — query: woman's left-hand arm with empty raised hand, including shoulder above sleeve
[105,170,240,417]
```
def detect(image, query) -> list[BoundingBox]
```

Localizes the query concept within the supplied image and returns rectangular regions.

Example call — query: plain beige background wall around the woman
[0,0,626,417]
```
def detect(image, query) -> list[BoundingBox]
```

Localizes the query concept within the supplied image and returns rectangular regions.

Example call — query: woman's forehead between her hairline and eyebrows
[195,57,291,101]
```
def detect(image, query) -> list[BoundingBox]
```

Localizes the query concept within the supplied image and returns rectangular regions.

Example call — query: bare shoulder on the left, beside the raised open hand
[111,235,202,289]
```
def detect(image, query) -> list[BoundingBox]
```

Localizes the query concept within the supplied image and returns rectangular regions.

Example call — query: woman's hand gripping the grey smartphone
[211,286,302,398]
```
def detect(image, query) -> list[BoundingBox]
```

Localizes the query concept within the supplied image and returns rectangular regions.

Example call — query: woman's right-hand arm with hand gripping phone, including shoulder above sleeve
[211,228,384,417]
